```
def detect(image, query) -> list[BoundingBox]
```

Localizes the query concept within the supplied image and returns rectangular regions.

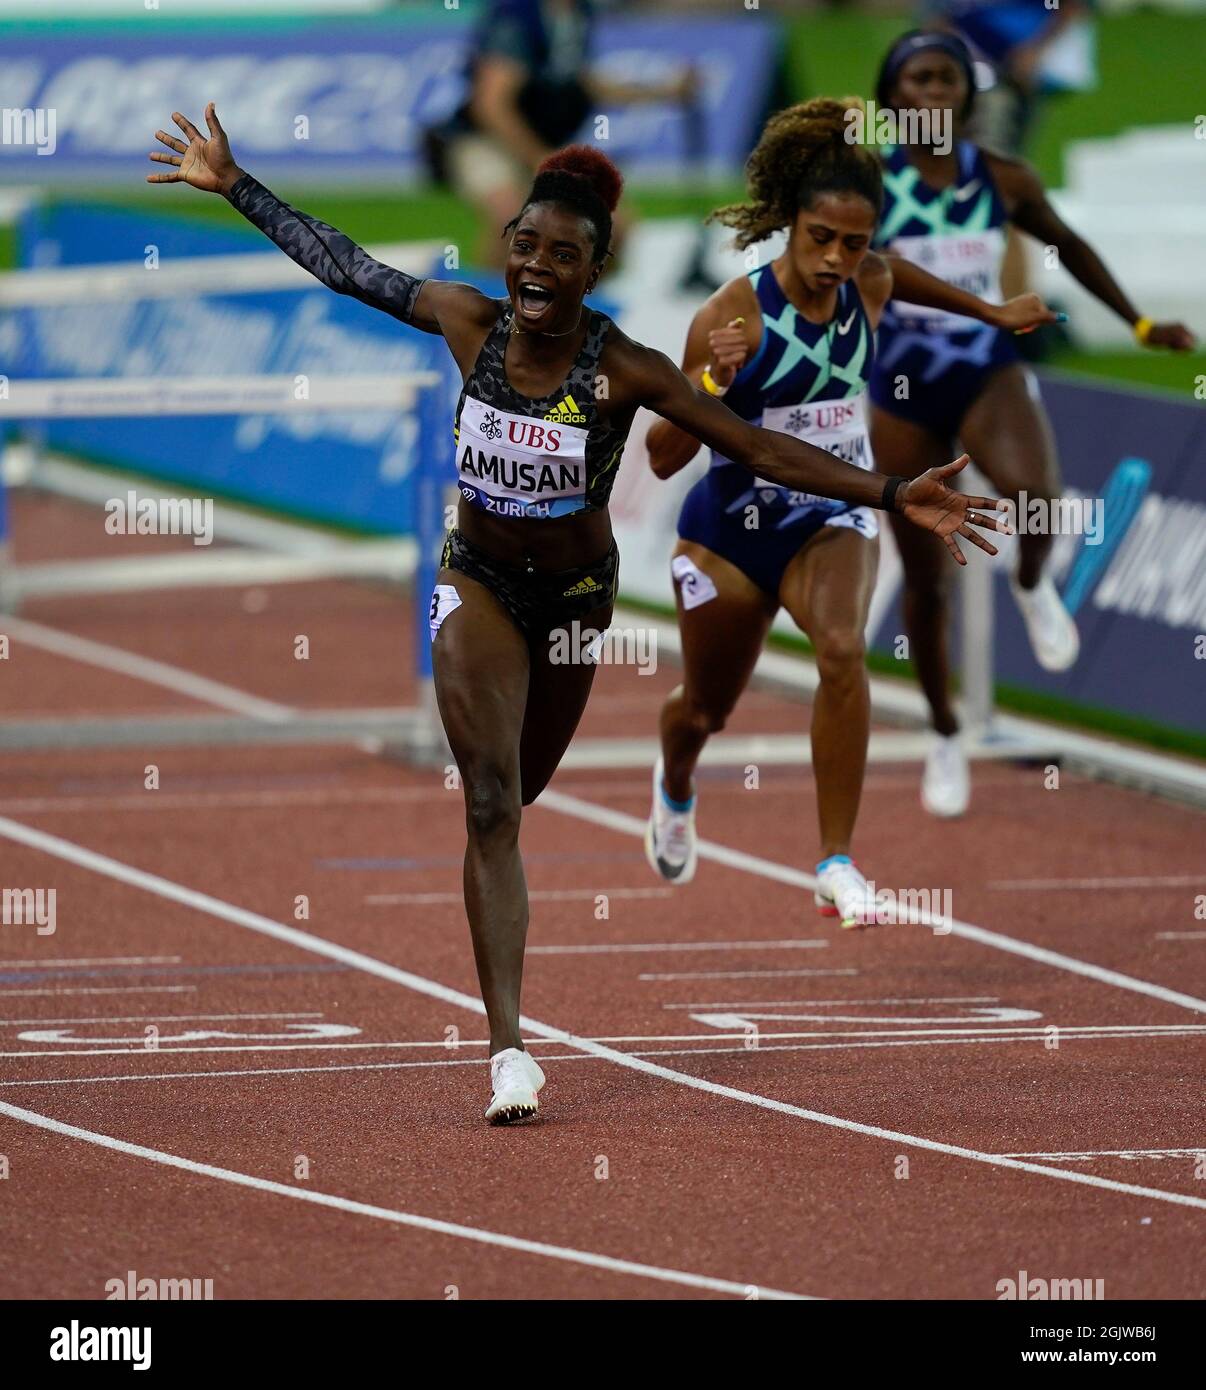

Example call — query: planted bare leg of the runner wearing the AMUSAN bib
[432,570,529,1055]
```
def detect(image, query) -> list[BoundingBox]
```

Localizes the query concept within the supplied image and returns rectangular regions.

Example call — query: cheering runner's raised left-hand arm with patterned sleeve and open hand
[147,101,493,336]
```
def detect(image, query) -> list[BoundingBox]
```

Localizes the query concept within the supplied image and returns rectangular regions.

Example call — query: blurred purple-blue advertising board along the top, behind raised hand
[0,6,778,185]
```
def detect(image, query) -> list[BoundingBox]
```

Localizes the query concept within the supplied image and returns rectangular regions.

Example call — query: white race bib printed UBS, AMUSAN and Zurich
[456,396,588,517]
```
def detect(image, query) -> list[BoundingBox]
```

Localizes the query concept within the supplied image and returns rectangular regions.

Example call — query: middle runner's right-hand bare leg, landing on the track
[779,527,879,859]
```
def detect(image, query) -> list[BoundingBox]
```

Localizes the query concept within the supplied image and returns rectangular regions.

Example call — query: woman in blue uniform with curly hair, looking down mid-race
[646,99,1055,927]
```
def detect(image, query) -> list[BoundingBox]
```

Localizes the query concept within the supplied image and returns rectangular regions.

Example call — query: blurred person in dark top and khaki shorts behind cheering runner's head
[427,0,695,268]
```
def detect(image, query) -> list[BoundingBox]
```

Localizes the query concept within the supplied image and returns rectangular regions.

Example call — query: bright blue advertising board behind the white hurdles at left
[0,203,452,534]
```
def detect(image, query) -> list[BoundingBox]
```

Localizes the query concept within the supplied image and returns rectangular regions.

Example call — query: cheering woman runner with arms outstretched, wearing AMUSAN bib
[149,103,1006,1123]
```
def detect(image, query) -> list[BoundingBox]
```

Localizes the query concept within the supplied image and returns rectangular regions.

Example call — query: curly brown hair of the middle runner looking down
[709,96,884,250]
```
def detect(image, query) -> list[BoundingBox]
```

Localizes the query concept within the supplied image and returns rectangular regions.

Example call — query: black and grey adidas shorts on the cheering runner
[432,528,620,642]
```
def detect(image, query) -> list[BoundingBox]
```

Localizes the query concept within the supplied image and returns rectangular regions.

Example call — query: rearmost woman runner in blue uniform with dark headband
[871,31,1193,816]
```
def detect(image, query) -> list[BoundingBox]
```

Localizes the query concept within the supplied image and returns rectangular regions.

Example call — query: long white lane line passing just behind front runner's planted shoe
[0,817,1206,1209]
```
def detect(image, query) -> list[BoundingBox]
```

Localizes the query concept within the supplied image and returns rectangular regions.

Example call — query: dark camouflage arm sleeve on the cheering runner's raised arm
[229,174,424,322]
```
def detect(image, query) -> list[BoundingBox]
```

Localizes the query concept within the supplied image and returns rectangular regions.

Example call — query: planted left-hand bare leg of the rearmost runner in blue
[871,406,959,735]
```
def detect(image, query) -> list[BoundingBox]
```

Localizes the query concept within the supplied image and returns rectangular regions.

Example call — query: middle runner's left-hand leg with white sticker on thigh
[661,541,778,801]
